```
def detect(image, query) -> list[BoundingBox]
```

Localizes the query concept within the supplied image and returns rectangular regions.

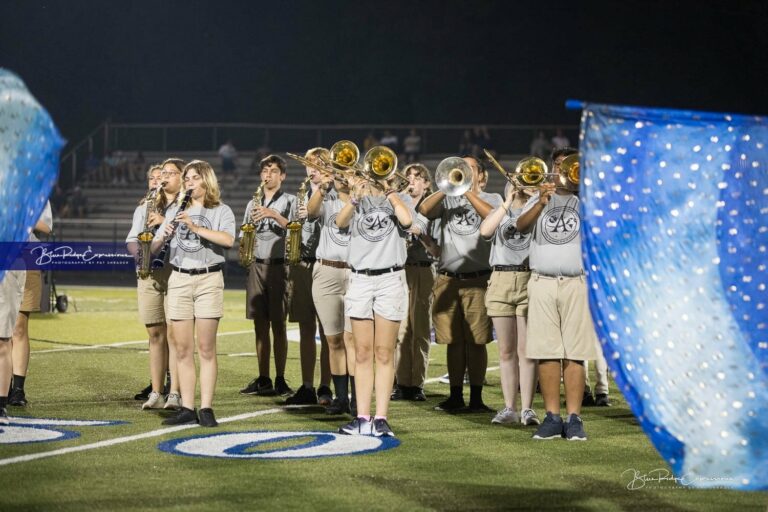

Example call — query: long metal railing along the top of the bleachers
[61,121,578,183]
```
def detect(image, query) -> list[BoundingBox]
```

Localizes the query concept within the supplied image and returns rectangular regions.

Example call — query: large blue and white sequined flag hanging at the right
[581,99,768,490]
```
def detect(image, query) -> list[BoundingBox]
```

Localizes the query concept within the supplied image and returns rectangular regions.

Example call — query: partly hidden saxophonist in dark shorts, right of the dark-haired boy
[285,148,333,406]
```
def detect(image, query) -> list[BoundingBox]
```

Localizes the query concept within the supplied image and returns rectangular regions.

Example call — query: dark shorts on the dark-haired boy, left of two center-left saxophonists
[245,262,288,322]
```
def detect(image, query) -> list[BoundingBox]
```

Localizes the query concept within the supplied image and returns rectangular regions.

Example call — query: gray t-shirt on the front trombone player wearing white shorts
[348,196,406,270]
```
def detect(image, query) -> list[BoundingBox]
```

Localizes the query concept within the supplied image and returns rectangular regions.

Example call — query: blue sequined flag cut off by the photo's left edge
[0,68,64,280]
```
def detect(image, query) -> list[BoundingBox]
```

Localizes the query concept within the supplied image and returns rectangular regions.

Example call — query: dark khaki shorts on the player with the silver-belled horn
[432,274,493,345]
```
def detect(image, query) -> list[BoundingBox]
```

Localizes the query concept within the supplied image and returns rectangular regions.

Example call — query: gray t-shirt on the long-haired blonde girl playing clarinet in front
[155,204,235,269]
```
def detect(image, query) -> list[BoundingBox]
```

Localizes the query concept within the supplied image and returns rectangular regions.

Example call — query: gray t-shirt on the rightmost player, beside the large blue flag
[520,193,584,276]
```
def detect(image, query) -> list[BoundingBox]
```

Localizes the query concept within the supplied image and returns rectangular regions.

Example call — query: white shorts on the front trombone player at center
[344,270,408,322]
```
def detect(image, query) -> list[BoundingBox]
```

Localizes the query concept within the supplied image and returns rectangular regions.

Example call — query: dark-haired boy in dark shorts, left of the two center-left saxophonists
[240,155,296,396]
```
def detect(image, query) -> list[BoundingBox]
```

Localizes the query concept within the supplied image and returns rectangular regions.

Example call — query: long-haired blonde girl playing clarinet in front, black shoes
[152,160,235,427]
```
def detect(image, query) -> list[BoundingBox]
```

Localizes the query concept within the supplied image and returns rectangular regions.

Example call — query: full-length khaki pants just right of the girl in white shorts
[396,265,435,387]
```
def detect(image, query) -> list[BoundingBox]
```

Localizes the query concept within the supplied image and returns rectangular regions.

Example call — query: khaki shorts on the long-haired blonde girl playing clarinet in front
[168,271,224,320]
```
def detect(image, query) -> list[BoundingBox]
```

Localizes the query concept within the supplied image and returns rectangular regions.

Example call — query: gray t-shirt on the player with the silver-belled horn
[438,192,503,273]
